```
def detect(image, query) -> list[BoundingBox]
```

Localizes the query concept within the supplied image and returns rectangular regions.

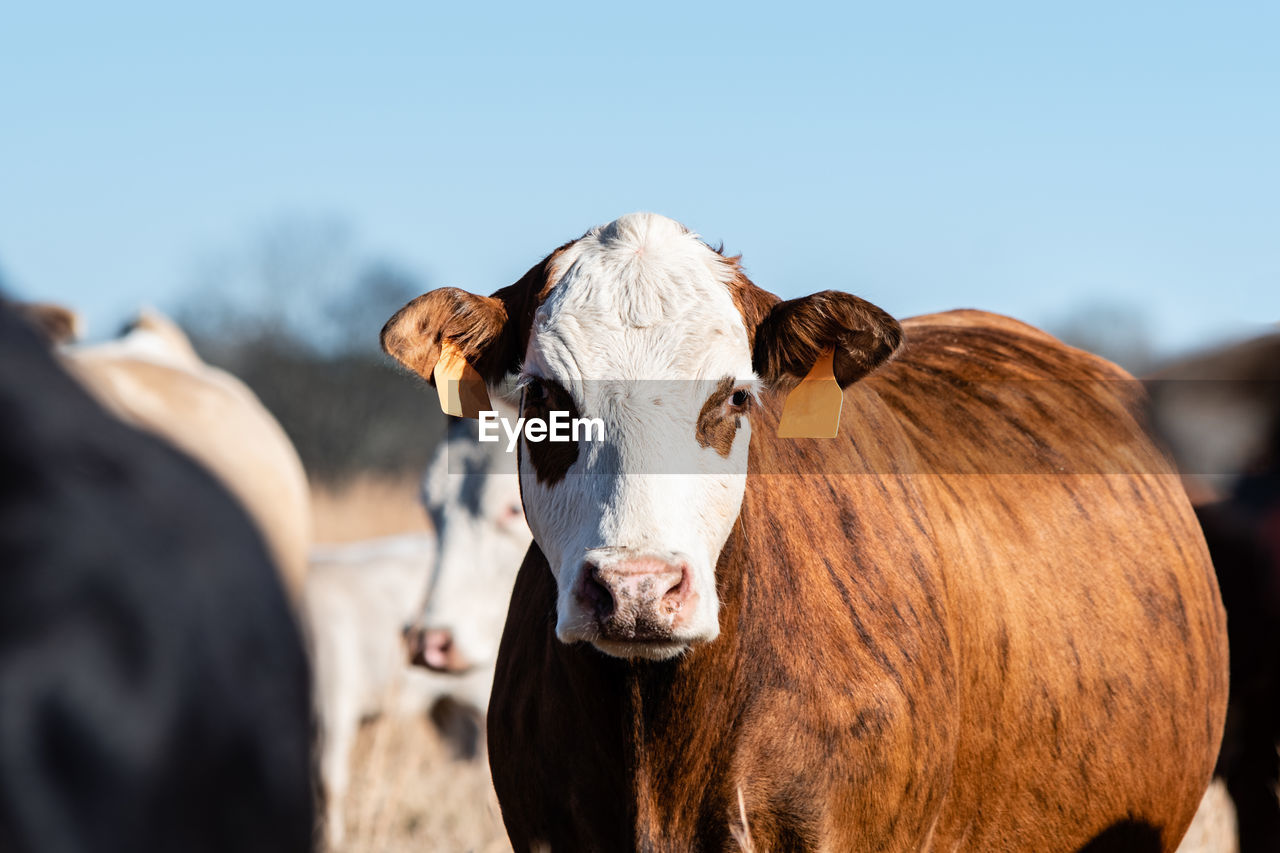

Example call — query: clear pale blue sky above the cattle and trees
[0,1,1280,350]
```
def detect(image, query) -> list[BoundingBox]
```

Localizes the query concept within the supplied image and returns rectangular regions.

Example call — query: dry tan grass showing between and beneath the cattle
[312,478,1238,853]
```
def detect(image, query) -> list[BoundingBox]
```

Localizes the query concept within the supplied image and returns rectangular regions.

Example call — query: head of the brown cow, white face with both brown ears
[383,214,901,660]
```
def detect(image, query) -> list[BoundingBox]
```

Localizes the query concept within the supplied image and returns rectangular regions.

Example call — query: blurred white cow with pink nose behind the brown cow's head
[305,402,531,848]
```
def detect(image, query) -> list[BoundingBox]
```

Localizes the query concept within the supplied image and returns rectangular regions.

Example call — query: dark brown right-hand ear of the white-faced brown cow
[751,291,902,388]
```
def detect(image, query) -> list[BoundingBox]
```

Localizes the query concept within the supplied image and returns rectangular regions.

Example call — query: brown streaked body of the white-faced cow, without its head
[489,311,1228,850]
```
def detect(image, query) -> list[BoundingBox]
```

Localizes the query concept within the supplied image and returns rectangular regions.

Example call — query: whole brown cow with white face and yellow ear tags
[383,214,1228,850]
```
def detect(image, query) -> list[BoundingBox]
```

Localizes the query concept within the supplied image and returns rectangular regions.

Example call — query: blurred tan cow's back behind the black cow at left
[60,311,311,601]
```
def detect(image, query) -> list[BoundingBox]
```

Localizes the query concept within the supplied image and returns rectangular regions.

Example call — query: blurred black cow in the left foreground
[0,305,314,853]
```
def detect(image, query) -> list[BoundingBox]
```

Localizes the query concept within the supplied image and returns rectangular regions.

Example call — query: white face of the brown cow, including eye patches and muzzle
[521,215,756,658]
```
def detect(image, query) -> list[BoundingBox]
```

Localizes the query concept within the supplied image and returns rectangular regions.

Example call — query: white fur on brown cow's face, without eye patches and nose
[521,214,756,658]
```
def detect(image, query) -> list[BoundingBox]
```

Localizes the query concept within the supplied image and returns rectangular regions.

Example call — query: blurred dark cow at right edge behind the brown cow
[1147,334,1280,853]
